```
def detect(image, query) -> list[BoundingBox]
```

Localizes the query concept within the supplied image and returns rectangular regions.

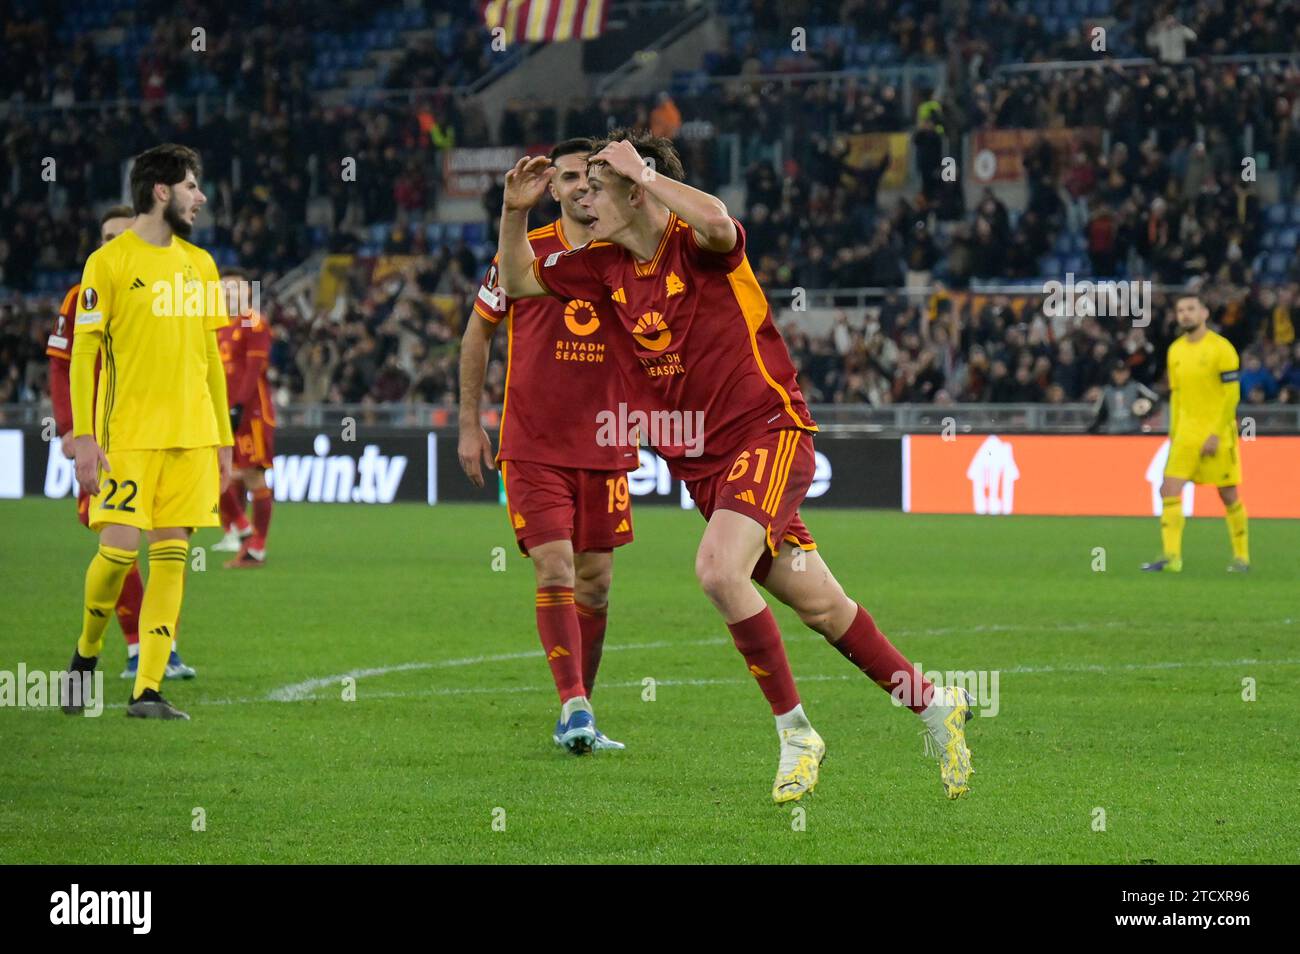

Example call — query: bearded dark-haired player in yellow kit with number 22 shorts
[61,143,234,719]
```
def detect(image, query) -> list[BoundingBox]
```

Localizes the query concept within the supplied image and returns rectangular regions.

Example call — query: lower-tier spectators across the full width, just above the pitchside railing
[0,253,1300,406]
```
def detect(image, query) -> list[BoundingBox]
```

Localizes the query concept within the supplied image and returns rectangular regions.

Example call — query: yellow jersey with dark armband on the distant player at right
[1169,330,1242,443]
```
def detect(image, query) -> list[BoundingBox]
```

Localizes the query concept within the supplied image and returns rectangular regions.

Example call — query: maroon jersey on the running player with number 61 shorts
[533,213,816,480]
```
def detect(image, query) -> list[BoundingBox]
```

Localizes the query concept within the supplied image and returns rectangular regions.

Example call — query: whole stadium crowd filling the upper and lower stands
[0,0,1300,404]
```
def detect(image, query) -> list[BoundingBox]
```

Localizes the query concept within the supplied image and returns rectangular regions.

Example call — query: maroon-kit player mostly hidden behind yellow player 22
[46,205,198,680]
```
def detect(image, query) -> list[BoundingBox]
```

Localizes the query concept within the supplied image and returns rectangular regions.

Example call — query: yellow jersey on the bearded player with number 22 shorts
[75,229,230,452]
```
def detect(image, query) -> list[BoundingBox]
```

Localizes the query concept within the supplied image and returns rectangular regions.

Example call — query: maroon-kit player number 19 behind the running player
[459,139,637,754]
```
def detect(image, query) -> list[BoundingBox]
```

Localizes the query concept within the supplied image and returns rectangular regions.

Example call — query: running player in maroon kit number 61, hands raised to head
[498,133,972,803]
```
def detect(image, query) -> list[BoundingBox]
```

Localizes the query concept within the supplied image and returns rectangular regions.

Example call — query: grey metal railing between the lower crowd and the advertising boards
[0,402,1300,438]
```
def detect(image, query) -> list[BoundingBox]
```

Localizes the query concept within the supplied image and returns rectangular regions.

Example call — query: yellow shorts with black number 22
[90,447,221,530]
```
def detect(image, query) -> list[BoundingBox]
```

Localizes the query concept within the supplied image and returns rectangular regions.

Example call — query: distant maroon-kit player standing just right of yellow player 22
[213,269,276,569]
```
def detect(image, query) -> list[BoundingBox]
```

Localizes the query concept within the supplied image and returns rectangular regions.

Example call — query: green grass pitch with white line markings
[0,499,1300,864]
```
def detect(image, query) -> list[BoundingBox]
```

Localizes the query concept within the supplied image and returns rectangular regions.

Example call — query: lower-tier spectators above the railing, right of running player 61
[780,286,1300,407]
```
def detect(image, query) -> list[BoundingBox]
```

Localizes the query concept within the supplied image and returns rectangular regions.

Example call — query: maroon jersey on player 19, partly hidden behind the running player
[475,220,638,471]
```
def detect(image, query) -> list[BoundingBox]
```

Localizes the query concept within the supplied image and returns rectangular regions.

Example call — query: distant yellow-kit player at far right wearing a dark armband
[1143,295,1251,573]
